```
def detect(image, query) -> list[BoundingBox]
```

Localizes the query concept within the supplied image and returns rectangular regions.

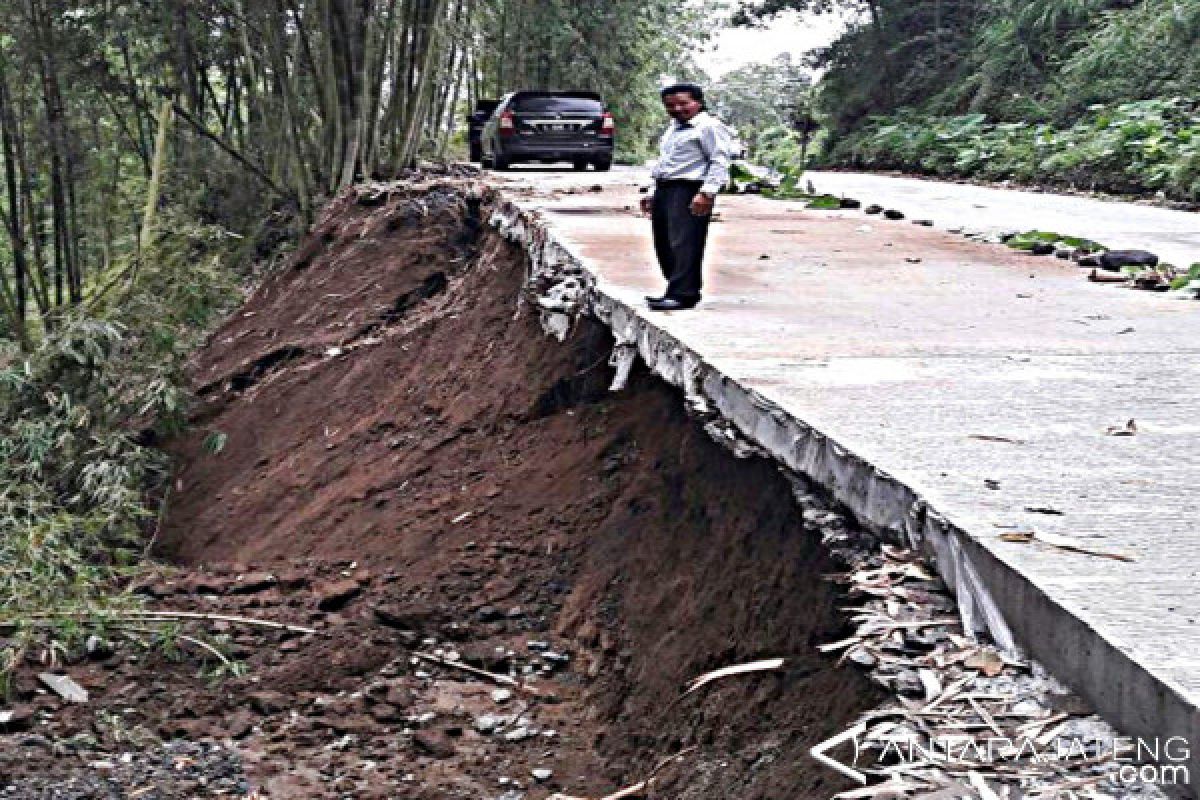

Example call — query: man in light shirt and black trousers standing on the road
[642,83,733,311]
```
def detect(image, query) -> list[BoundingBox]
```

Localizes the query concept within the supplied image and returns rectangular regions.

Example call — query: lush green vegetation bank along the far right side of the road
[742,0,1200,204]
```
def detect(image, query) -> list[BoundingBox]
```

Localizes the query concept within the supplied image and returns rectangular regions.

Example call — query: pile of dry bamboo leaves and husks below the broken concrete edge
[818,542,1160,800]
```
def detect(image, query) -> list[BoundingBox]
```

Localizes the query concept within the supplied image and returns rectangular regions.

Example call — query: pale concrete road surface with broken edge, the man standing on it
[498,169,1200,796]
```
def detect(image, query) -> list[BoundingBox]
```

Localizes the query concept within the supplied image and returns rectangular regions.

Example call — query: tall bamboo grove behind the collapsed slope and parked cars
[0,0,698,347]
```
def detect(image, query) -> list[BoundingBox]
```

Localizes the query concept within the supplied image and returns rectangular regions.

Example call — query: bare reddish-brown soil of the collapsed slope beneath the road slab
[0,186,878,800]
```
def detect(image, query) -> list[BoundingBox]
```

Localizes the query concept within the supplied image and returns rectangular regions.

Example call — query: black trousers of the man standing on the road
[650,181,709,300]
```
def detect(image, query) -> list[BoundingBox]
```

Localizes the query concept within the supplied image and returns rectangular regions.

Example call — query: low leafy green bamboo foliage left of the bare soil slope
[0,216,239,682]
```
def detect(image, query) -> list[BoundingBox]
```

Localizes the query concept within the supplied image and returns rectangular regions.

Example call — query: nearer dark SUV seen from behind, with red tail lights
[481,91,617,170]
